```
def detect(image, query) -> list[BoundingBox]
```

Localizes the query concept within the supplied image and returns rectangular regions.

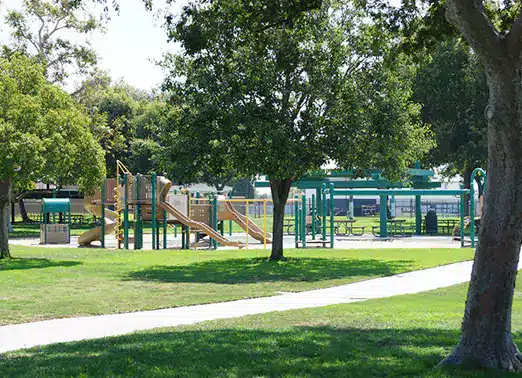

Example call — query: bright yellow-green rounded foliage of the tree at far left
[0,54,105,191]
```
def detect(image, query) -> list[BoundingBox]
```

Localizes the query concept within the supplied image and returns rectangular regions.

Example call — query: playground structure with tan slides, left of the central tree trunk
[78,162,271,249]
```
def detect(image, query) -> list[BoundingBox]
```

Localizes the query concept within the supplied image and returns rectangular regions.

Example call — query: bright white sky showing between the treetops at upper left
[0,0,401,89]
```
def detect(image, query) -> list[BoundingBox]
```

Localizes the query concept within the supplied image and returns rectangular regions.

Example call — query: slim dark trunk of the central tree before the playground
[270,179,292,261]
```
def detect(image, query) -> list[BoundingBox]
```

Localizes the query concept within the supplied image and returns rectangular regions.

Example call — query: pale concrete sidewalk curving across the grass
[0,261,480,353]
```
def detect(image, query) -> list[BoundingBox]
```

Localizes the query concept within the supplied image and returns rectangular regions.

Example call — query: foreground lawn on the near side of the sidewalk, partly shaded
[4,285,522,378]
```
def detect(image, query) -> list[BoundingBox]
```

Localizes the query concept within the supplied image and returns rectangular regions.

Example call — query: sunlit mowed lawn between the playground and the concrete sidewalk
[0,246,473,325]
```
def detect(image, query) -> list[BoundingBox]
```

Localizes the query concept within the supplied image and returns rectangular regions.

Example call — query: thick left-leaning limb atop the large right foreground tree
[446,0,501,60]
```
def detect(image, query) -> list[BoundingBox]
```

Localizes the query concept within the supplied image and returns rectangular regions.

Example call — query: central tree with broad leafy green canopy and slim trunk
[157,0,431,257]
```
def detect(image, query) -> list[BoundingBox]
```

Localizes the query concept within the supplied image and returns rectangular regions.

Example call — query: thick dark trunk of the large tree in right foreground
[441,59,522,371]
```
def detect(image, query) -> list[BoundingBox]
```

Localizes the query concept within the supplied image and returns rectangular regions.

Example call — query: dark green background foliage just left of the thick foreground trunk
[414,39,488,176]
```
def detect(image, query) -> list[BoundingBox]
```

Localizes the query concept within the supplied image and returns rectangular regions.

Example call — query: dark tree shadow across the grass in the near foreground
[0,327,512,378]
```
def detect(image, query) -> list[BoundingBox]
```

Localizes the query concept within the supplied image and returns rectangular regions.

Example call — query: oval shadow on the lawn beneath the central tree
[126,258,413,284]
